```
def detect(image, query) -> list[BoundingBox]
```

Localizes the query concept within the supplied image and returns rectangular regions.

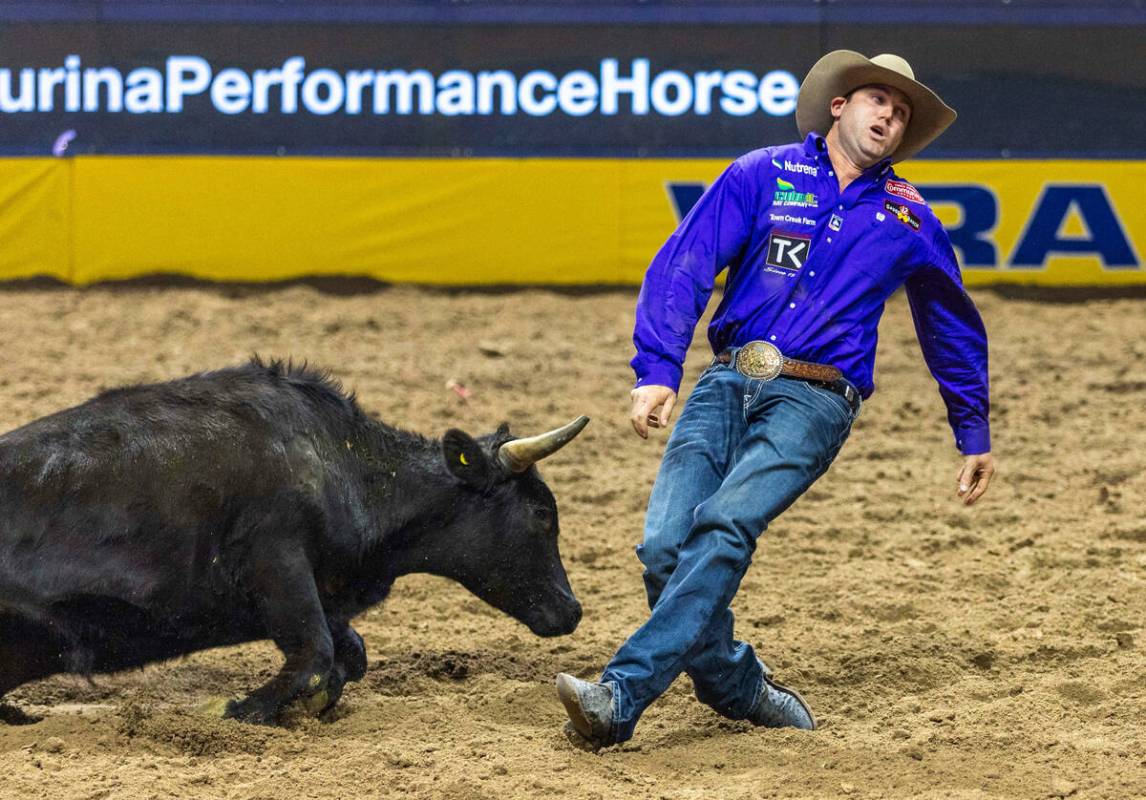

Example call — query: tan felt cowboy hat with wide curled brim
[795,50,955,162]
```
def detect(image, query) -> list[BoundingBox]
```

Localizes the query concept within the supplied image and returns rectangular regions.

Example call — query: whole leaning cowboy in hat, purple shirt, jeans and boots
[557,50,995,747]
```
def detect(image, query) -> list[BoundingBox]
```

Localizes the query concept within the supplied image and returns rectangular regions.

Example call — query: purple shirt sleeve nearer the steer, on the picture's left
[631,154,754,391]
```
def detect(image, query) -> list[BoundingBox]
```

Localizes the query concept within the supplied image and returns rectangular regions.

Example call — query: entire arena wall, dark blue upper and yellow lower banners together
[0,0,1146,285]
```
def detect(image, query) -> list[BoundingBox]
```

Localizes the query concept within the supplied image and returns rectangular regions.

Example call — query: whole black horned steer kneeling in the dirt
[0,359,588,723]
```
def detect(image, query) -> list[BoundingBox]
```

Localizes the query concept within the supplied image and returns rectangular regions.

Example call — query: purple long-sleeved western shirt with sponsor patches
[633,133,990,455]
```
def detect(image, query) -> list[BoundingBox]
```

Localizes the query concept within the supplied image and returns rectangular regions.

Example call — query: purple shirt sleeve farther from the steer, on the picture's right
[904,227,991,455]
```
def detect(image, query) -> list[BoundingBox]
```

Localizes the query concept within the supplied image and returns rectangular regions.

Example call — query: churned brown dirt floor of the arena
[0,284,1146,800]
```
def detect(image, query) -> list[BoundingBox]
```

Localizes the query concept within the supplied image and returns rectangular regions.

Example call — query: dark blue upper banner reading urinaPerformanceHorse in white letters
[0,0,1146,158]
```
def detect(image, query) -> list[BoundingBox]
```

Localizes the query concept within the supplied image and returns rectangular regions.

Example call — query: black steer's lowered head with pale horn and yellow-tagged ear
[433,416,589,636]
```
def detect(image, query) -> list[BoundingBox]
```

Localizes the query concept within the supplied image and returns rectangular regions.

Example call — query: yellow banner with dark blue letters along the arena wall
[0,156,1146,285]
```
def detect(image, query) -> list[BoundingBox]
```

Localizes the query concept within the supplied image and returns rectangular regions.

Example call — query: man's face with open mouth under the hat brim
[832,85,911,168]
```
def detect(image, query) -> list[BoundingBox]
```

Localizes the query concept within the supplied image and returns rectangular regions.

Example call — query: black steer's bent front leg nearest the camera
[223,550,332,724]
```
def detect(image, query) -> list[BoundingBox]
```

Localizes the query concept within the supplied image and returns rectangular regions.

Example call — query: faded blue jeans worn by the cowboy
[601,363,855,742]
